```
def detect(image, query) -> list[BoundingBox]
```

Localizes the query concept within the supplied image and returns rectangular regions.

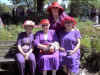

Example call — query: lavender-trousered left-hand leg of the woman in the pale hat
[16,53,25,75]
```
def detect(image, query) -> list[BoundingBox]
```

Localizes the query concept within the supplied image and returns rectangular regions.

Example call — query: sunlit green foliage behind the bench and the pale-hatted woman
[0,25,40,40]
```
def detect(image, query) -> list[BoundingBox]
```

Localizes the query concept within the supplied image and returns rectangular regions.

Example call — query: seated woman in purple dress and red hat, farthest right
[59,17,81,75]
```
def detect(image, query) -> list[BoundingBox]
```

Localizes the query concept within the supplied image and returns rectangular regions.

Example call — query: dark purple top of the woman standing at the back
[48,12,68,30]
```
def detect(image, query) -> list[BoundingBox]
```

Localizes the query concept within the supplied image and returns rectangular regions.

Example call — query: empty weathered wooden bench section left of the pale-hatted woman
[0,41,17,73]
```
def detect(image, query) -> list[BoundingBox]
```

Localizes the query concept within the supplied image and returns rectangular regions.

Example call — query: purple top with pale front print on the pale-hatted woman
[17,32,34,52]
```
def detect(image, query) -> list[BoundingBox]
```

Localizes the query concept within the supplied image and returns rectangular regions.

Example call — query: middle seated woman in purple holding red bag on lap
[35,19,59,75]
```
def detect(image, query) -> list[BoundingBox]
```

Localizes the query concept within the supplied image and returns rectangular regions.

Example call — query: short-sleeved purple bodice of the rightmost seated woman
[59,30,81,50]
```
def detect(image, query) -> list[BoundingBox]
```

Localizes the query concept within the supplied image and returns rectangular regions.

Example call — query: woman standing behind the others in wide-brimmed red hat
[47,2,68,30]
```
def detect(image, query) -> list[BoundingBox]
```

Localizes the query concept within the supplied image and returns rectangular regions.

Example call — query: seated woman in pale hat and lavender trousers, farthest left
[16,20,36,75]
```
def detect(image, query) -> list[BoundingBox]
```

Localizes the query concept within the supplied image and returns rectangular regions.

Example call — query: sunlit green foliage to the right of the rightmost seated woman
[76,19,100,51]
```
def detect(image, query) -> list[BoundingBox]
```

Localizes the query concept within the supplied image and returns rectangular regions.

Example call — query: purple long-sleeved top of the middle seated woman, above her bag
[34,30,58,46]
